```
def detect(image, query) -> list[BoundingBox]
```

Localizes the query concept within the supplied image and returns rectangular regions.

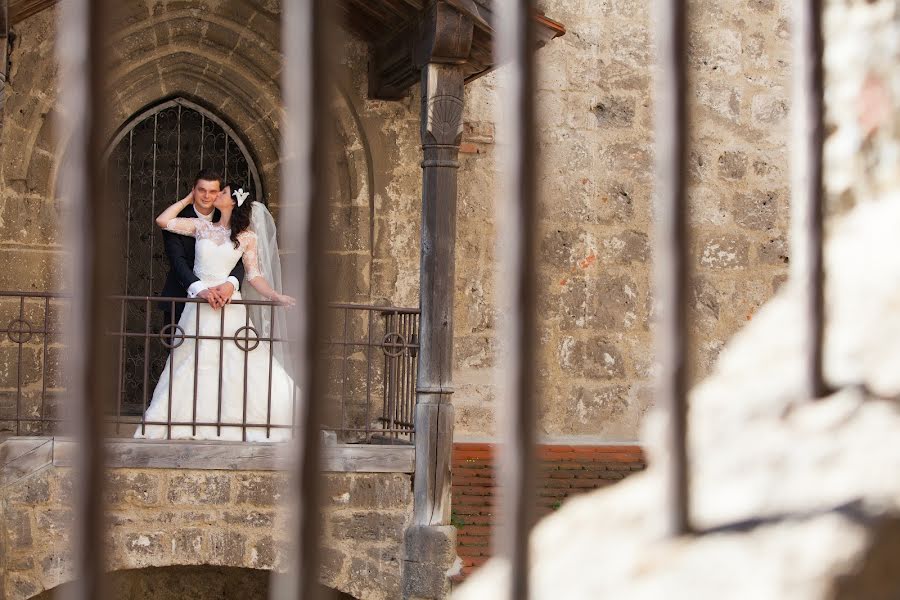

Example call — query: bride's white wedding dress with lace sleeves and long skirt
[134,218,298,442]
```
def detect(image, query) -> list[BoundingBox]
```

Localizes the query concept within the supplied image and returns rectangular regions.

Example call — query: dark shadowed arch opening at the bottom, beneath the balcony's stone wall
[34,565,356,600]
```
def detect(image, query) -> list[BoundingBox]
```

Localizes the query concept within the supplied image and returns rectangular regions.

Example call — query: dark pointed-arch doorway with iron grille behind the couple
[107,98,264,414]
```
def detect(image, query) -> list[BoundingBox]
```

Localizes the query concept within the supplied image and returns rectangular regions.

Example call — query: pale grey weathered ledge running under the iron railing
[0,437,415,487]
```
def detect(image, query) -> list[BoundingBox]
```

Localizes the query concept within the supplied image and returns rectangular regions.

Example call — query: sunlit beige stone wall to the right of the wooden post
[454,0,790,440]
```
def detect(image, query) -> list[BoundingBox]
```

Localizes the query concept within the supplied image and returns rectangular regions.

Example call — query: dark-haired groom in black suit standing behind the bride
[160,169,244,323]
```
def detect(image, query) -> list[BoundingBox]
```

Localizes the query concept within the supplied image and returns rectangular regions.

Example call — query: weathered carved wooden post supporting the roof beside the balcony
[415,63,463,525]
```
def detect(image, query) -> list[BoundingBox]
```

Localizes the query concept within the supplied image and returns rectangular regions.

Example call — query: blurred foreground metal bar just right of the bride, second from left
[276,0,340,600]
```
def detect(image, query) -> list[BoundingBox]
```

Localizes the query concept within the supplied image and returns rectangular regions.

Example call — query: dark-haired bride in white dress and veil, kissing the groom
[134,186,297,442]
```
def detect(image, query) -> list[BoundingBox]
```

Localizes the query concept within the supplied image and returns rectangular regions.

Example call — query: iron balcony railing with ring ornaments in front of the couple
[0,292,419,443]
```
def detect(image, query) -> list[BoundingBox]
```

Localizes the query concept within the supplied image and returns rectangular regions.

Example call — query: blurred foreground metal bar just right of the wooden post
[495,0,539,599]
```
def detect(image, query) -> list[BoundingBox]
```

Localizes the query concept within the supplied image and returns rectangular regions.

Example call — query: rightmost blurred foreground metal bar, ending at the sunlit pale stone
[791,0,828,398]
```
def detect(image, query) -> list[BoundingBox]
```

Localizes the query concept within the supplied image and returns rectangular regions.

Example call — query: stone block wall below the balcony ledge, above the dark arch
[0,466,412,600]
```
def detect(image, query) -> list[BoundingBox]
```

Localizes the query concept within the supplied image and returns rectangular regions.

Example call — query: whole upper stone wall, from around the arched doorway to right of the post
[0,0,789,441]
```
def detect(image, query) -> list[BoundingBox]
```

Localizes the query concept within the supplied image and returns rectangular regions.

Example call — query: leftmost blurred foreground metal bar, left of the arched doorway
[56,0,111,600]
